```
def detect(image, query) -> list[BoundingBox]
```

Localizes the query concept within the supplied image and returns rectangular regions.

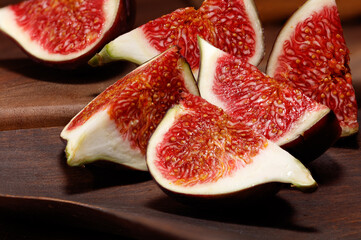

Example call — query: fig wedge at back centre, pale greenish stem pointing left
[89,0,264,75]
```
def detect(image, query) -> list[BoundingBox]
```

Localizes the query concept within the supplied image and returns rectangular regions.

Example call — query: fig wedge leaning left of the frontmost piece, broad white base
[61,47,199,171]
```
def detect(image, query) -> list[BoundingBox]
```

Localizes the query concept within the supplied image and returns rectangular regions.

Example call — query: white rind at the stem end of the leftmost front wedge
[60,108,147,171]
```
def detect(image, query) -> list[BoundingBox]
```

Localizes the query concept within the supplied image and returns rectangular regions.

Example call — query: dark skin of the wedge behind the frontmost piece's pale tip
[281,111,342,164]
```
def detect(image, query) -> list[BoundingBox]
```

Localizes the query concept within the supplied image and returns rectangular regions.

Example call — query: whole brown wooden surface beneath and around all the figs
[0,0,361,239]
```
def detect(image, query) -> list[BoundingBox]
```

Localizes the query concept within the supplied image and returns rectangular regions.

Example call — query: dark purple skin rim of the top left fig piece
[1,0,136,70]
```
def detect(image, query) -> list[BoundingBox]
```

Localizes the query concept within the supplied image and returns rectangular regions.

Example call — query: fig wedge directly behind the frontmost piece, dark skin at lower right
[198,38,341,163]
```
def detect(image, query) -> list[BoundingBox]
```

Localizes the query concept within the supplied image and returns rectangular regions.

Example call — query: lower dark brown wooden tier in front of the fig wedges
[0,122,361,239]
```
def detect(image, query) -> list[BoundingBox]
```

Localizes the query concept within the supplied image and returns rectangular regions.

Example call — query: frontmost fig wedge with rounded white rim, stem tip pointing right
[146,94,317,202]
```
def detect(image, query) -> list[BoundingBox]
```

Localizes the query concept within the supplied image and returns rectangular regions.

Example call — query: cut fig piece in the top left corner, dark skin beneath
[0,0,134,68]
